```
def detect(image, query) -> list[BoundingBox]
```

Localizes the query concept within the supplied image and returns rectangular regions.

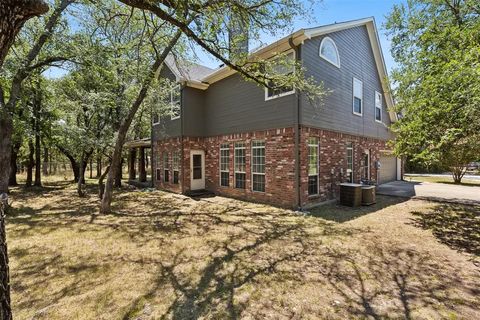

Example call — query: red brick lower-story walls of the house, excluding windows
[153,127,394,208]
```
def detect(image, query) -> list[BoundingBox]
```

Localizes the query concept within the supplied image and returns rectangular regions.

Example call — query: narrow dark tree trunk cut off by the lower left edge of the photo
[0,193,12,320]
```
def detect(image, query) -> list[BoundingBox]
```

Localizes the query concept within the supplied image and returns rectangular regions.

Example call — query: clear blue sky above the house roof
[198,0,406,71]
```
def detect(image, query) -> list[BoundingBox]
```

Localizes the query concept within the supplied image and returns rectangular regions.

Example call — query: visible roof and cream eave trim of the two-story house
[167,17,397,122]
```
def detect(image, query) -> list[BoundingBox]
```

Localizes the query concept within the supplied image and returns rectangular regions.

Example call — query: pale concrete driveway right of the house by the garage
[377,181,480,204]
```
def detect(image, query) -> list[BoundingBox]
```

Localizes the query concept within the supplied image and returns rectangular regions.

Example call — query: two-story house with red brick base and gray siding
[152,18,401,208]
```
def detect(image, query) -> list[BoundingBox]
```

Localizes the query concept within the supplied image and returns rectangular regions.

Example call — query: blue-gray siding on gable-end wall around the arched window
[300,26,393,140]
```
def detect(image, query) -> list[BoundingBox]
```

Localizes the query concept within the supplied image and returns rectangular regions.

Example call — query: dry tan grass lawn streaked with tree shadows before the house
[7,178,480,319]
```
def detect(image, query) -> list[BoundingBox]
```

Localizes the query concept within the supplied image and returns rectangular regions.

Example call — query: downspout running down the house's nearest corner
[288,37,302,210]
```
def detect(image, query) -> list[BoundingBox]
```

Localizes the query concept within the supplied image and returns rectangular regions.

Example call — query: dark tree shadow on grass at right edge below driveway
[412,204,480,256]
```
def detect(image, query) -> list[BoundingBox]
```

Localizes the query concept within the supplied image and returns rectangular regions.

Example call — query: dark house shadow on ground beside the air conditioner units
[309,195,409,223]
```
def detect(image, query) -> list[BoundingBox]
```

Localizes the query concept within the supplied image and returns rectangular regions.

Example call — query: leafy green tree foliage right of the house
[386,0,480,172]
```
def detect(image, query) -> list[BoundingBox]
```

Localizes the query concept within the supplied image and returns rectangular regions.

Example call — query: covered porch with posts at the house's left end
[125,138,153,188]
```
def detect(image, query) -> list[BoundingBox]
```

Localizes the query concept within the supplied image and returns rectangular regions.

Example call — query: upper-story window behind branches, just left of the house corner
[265,51,295,100]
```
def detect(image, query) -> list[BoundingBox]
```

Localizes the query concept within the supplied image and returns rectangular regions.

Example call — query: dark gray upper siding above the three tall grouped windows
[204,74,296,136]
